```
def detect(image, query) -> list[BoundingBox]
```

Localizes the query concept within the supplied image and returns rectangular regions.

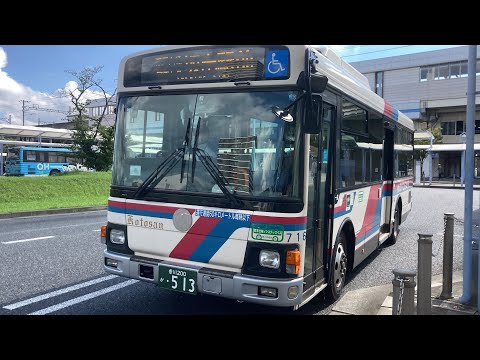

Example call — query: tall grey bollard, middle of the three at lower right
[417,234,433,315]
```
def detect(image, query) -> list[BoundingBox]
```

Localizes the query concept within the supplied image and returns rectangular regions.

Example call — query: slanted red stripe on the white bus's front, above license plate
[170,217,222,260]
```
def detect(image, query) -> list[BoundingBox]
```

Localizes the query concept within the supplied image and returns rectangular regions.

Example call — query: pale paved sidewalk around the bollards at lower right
[329,271,480,315]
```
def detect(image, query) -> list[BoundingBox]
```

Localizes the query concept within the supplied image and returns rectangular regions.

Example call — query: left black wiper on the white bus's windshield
[133,118,191,199]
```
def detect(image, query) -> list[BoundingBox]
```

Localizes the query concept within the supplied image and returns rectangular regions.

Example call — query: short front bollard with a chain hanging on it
[392,269,416,315]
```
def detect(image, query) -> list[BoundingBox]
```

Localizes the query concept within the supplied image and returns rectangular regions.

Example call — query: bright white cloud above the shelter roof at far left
[0,47,108,125]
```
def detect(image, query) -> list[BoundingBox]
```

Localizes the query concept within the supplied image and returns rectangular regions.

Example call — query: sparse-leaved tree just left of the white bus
[65,66,116,171]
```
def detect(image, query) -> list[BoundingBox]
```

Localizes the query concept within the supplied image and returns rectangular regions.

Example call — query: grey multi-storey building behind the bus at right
[351,46,480,183]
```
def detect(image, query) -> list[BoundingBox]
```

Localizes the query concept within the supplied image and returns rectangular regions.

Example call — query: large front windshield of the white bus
[113,91,301,198]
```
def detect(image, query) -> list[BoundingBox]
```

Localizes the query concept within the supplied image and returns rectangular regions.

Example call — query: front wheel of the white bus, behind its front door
[326,230,348,301]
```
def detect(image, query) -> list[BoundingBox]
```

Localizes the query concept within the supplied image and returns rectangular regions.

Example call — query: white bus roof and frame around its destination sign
[118,45,414,131]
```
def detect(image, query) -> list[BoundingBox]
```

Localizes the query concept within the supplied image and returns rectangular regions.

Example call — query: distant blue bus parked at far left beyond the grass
[5,146,79,176]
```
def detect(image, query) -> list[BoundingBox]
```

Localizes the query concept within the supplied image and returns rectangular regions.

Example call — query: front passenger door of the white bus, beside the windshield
[304,96,336,296]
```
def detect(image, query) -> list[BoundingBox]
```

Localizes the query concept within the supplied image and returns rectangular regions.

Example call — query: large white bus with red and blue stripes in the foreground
[102,45,414,309]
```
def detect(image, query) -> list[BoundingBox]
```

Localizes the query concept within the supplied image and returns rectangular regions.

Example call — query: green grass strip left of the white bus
[0,172,112,213]
